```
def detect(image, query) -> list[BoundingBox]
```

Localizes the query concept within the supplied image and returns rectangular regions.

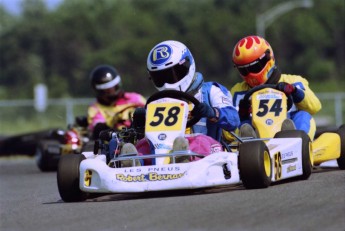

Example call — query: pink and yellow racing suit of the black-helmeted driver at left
[88,92,146,138]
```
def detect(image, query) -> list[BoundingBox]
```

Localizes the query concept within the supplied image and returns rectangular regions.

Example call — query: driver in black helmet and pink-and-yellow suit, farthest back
[88,65,146,139]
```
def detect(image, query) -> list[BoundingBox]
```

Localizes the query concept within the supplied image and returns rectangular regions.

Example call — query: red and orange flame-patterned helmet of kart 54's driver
[232,36,275,87]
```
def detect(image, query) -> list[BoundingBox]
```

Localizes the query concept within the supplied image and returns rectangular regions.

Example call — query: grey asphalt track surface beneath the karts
[0,157,345,231]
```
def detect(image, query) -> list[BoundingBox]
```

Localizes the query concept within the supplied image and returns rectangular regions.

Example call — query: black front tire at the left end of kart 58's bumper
[57,154,88,202]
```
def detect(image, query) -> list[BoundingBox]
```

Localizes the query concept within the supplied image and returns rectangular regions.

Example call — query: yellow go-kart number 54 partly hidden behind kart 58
[236,84,345,169]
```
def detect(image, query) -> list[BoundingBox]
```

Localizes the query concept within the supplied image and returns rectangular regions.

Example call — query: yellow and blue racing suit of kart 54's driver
[231,69,321,140]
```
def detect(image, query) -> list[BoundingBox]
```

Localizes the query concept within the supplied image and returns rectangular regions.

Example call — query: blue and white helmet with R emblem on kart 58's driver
[147,40,195,92]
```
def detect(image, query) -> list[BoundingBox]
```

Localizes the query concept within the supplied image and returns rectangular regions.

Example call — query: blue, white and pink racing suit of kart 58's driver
[136,73,240,165]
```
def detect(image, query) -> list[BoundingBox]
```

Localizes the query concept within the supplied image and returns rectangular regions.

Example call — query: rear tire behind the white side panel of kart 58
[274,130,313,180]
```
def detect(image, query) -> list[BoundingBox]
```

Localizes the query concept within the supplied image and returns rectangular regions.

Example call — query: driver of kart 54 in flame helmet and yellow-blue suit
[231,36,321,139]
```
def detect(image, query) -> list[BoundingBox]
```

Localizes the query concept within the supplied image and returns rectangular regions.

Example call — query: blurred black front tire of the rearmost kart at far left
[35,140,61,172]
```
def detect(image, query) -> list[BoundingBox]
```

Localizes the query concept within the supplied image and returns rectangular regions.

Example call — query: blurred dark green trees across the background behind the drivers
[0,0,345,98]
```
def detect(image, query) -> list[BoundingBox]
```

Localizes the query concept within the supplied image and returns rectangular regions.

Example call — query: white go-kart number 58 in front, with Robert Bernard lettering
[57,90,311,202]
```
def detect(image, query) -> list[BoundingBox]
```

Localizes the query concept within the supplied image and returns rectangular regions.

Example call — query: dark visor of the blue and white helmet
[149,59,190,87]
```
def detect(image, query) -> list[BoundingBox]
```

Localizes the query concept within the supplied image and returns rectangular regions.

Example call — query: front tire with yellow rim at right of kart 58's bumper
[238,140,272,189]
